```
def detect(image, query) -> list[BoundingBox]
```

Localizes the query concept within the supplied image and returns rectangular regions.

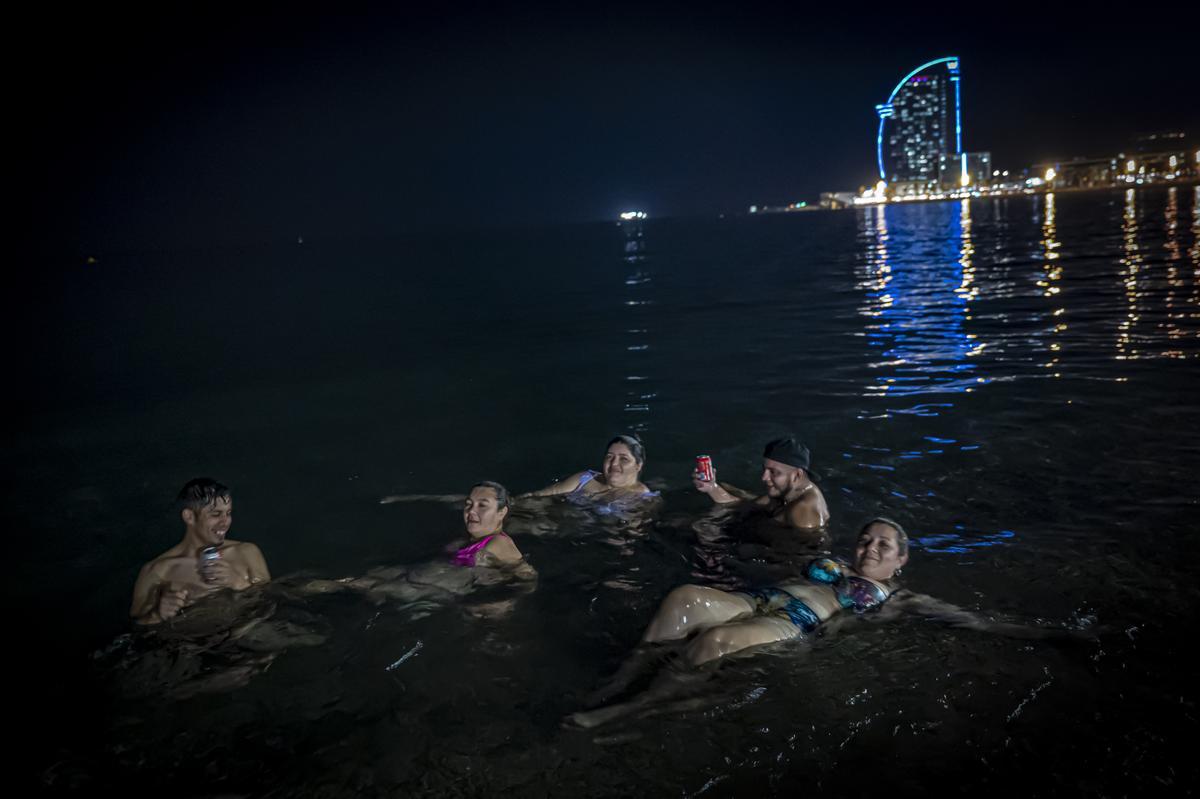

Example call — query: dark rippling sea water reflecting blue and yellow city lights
[11,186,1200,797]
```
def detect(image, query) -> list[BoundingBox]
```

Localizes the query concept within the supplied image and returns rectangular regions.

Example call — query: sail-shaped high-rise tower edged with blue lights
[875,55,970,194]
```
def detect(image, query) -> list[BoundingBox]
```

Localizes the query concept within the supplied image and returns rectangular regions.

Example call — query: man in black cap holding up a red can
[691,438,829,530]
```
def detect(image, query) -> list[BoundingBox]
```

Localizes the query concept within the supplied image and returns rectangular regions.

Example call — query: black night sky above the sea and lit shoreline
[18,4,1200,253]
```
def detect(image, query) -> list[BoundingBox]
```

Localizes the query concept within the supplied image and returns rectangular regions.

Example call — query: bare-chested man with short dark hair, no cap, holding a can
[130,477,271,624]
